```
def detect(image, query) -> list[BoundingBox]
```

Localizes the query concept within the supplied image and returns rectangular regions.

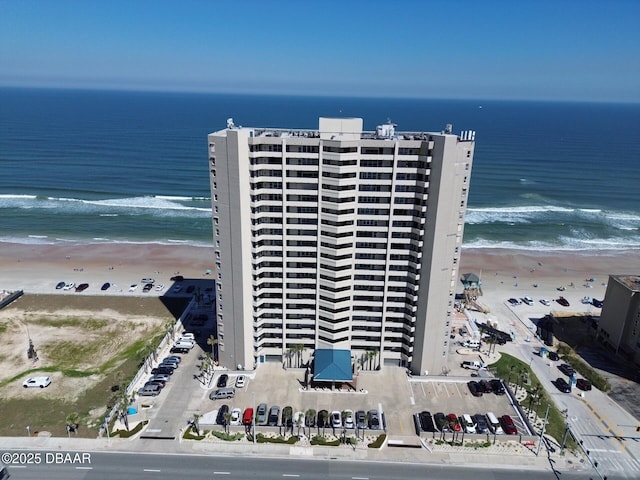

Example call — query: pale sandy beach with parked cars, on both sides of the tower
[0,243,640,301]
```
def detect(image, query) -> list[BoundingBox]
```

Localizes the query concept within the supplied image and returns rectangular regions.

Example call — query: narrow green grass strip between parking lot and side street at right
[491,353,578,450]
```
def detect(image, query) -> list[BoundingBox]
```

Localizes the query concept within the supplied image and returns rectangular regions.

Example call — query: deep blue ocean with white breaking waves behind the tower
[0,88,640,253]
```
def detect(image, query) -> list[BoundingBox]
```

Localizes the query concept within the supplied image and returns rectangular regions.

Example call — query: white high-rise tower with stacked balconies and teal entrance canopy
[208,118,475,380]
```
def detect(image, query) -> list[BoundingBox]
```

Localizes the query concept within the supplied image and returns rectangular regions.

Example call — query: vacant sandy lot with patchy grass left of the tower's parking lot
[0,295,174,434]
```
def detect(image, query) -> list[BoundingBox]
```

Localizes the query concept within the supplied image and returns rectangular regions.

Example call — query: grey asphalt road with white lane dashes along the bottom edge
[2,452,585,480]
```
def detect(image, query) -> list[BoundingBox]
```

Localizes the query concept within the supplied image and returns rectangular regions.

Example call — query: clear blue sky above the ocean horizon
[0,0,640,102]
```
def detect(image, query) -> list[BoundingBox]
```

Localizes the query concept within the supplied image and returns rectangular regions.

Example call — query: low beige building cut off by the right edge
[597,275,640,365]
